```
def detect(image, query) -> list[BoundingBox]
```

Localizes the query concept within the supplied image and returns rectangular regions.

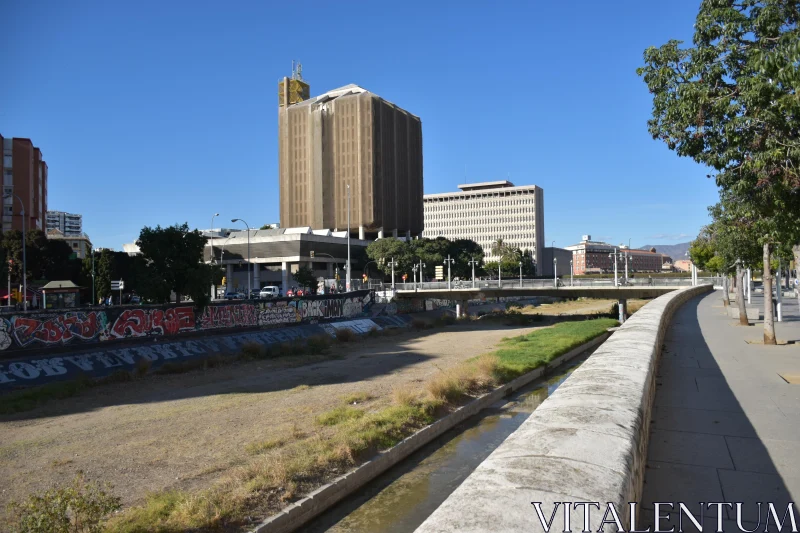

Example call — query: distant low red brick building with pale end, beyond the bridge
[566,235,672,275]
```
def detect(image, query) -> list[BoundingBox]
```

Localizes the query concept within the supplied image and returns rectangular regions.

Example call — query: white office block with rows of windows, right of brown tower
[422,181,544,265]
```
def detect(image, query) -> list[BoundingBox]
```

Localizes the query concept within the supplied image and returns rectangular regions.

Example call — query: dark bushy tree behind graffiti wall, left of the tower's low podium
[136,223,216,308]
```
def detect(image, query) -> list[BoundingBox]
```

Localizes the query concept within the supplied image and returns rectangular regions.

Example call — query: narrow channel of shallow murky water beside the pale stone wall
[303,350,594,533]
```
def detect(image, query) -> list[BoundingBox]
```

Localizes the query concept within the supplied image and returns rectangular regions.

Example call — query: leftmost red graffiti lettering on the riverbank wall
[11,311,108,347]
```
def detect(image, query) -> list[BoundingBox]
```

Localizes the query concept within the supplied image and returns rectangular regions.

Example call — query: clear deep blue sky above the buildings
[0,0,717,249]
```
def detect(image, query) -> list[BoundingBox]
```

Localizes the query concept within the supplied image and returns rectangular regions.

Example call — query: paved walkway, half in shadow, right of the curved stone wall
[639,291,800,531]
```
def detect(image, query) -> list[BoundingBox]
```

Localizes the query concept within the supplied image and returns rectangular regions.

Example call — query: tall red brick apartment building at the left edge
[0,135,47,232]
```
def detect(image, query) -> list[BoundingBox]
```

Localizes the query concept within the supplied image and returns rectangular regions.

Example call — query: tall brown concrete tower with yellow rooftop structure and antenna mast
[278,71,423,239]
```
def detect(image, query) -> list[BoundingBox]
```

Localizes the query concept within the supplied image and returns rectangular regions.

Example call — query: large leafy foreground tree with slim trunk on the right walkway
[637,0,800,344]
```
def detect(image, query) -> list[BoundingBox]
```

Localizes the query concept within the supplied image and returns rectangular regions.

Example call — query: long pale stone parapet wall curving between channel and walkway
[416,285,712,533]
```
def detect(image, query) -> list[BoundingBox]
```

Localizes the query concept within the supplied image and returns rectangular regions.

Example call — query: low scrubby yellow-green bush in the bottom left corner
[11,474,122,533]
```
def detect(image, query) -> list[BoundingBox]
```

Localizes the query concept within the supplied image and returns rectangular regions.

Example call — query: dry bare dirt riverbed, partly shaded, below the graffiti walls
[0,323,544,507]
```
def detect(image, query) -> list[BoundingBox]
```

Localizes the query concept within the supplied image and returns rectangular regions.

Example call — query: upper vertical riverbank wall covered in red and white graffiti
[0,291,372,352]
